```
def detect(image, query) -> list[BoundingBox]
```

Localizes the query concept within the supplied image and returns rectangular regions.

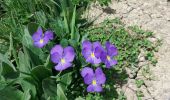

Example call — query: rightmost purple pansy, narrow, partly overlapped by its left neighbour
[100,41,118,68]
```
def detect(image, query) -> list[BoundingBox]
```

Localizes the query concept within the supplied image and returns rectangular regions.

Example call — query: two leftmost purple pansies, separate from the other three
[32,28,75,71]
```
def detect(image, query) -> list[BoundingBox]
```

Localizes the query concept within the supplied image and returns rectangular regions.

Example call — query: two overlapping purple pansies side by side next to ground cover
[82,41,118,68]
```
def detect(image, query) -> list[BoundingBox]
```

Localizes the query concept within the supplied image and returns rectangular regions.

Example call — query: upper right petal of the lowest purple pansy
[95,68,106,84]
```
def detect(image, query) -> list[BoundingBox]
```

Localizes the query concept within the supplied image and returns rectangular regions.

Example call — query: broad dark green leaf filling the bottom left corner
[0,87,23,100]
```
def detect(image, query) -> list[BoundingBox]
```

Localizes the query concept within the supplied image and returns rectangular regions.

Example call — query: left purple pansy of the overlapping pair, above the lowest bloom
[82,41,102,64]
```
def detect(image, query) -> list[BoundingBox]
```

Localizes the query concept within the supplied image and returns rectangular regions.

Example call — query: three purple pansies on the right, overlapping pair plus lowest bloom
[81,41,118,92]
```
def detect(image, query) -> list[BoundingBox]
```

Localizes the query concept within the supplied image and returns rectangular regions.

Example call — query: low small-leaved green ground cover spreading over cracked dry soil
[82,18,159,68]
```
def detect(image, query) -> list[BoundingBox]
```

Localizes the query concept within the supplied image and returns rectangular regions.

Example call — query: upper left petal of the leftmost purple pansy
[32,27,43,42]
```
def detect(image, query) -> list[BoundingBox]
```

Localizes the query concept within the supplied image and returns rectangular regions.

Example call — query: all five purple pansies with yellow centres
[32,28,118,92]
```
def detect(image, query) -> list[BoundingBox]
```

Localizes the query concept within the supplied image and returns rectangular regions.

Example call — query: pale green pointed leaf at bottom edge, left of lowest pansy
[57,84,67,100]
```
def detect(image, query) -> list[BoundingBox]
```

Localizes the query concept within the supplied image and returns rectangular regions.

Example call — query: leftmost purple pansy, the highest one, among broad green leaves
[32,27,53,48]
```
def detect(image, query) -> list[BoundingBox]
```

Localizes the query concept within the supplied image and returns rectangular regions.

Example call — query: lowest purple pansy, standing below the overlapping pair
[81,67,106,92]
